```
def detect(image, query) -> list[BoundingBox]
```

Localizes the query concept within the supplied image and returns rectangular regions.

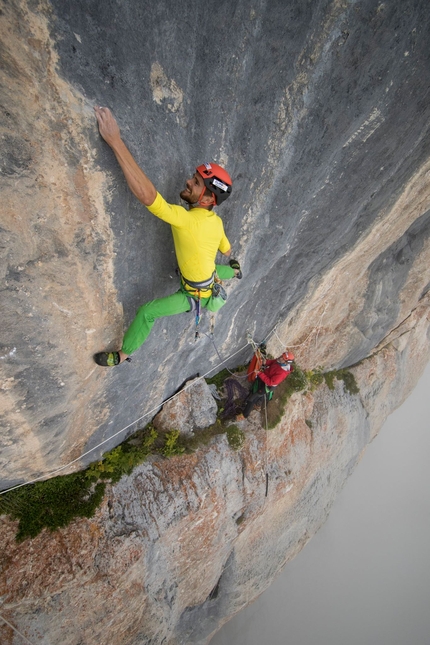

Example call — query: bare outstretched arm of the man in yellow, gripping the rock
[94,107,157,206]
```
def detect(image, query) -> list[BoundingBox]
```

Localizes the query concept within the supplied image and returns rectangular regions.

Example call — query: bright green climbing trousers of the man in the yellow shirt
[121,264,234,355]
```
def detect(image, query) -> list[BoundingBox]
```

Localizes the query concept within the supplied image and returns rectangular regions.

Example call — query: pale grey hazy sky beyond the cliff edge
[211,364,430,645]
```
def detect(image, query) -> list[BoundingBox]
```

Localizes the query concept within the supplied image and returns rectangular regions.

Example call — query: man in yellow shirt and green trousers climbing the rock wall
[94,107,242,367]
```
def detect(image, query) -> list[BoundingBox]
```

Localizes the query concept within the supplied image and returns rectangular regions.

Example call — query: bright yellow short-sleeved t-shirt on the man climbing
[147,193,230,288]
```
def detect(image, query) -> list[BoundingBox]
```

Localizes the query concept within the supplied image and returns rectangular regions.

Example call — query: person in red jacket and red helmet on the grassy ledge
[243,350,294,419]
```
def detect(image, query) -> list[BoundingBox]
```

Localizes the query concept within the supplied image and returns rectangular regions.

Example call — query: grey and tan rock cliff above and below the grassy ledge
[0,0,430,645]
